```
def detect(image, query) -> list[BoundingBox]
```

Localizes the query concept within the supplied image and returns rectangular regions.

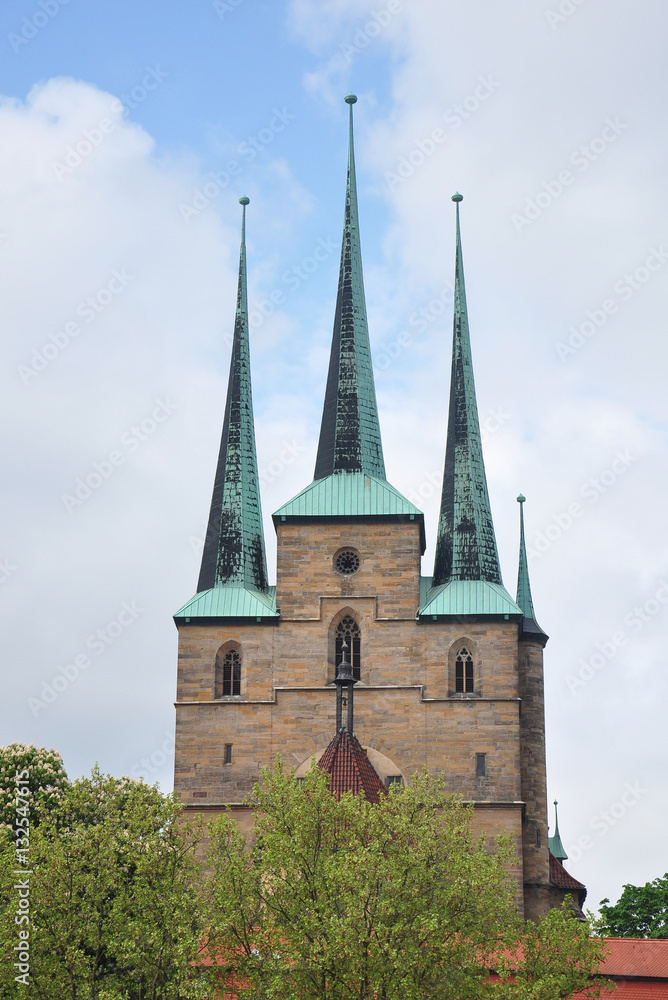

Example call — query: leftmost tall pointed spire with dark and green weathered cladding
[197,198,268,593]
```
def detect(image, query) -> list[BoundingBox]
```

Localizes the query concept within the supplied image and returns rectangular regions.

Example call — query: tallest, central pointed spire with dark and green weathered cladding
[313,94,385,480]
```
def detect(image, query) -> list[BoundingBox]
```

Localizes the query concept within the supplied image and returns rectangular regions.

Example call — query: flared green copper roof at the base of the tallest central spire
[273,472,424,552]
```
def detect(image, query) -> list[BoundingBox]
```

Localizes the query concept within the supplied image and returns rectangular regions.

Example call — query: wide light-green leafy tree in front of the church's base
[204,761,603,1000]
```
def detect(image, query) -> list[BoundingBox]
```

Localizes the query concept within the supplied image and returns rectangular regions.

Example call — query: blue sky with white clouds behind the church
[0,0,668,909]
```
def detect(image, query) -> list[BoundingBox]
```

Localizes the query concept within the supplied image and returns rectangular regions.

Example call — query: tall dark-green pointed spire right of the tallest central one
[434,194,502,587]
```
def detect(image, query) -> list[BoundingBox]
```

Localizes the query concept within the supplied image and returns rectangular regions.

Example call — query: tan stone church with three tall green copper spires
[174,94,586,919]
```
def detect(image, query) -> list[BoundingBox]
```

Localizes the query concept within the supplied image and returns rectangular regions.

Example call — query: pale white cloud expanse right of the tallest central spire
[292,0,668,906]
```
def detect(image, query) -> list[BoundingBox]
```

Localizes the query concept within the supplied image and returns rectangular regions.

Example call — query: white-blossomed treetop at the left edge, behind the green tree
[0,743,69,827]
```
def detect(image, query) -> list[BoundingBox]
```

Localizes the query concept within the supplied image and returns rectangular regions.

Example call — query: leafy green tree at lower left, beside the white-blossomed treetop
[0,769,206,1000]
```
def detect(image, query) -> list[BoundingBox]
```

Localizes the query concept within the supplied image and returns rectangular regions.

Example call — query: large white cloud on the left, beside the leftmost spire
[0,79,245,785]
